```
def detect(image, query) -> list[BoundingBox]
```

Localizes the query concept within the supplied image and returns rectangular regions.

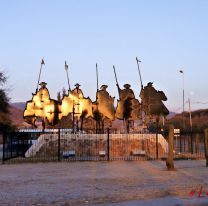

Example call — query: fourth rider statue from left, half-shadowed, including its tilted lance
[114,67,141,132]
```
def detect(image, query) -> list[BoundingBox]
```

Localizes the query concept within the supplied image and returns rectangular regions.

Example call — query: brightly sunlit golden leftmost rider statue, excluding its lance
[23,82,61,129]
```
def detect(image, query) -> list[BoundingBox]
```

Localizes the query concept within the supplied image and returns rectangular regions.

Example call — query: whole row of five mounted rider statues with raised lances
[24,58,169,132]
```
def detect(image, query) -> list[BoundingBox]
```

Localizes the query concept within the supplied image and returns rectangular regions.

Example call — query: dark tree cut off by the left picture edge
[0,71,11,131]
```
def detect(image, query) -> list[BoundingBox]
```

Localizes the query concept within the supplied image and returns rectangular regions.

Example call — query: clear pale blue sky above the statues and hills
[0,0,208,112]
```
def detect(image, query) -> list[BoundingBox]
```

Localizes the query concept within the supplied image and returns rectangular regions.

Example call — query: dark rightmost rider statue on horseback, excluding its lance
[140,82,169,122]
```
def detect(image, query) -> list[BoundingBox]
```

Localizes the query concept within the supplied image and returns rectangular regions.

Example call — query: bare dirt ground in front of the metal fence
[0,160,208,206]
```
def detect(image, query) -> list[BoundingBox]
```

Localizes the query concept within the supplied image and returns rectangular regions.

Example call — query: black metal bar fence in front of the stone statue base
[2,129,205,163]
